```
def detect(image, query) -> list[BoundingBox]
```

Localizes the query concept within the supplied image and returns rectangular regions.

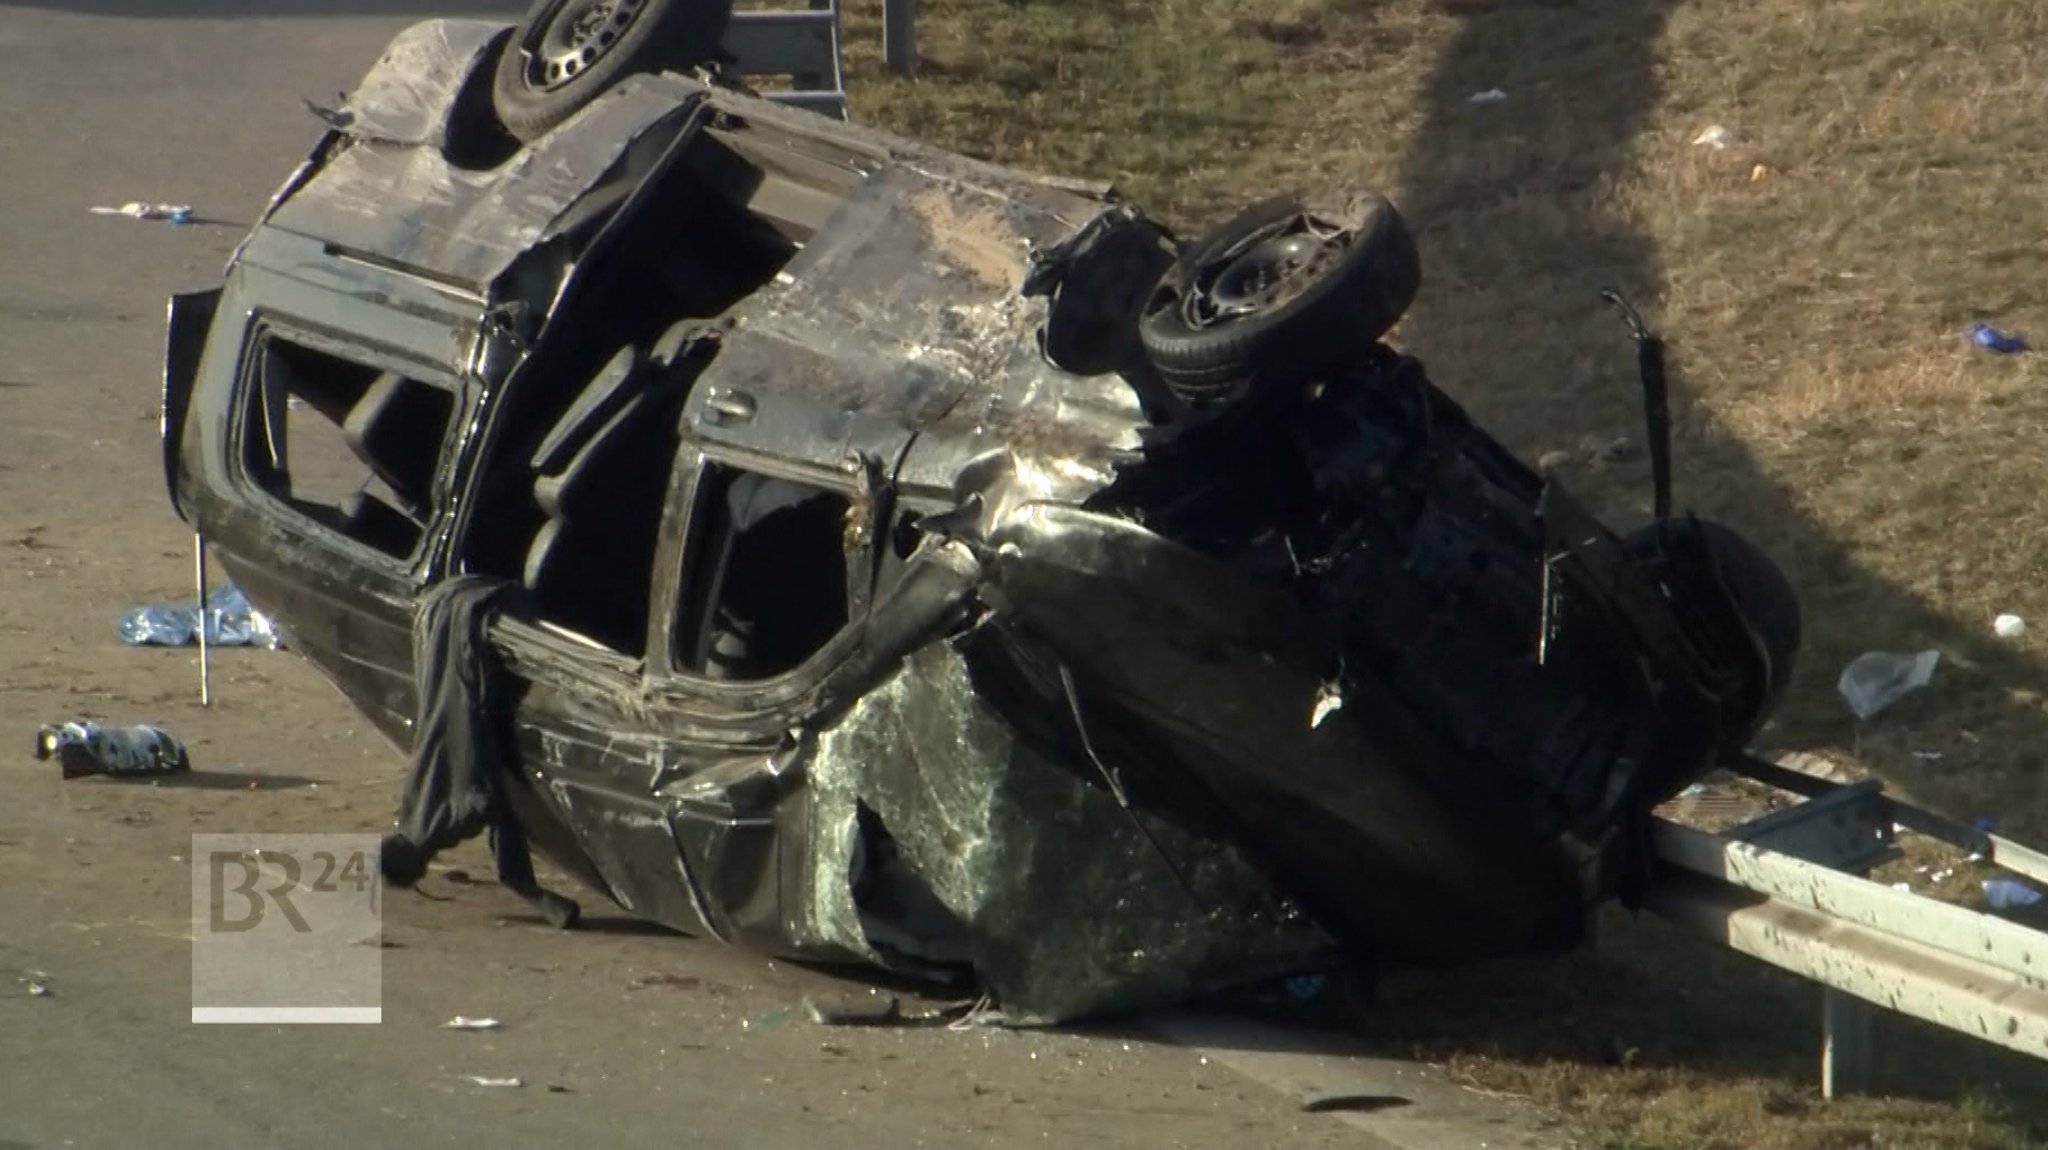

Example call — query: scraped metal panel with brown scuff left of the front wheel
[686,166,1143,474]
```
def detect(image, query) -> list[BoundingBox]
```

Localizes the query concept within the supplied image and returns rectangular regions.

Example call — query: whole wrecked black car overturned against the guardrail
[164,4,1800,1021]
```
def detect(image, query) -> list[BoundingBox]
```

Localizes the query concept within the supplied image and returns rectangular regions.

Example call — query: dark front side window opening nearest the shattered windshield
[674,465,852,681]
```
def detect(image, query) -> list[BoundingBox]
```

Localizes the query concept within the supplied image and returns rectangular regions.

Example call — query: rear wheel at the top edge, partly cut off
[492,0,731,143]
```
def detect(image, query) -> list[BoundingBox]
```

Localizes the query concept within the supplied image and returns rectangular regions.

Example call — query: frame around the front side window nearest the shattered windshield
[647,434,879,687]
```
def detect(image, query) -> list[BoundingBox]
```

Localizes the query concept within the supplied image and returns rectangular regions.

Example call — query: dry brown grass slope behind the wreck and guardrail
[827,0,2048,1148]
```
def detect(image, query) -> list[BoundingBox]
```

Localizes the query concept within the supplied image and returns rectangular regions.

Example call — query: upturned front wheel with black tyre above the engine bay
[1139,192,1421,405]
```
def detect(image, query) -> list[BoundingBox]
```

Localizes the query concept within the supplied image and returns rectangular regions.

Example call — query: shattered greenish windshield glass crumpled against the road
[790,643,1333,1025]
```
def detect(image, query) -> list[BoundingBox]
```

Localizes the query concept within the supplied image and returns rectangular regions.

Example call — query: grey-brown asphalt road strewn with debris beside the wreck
[0,0,1548,1150]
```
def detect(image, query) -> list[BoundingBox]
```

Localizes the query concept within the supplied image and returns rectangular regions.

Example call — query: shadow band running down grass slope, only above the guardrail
[1395,0,2048,839]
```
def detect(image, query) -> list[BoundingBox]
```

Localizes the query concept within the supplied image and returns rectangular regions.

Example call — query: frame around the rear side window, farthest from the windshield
[227,311,473,573]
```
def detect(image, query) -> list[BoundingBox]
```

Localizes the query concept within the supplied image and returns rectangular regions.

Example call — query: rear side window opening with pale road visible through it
[242,334,455,559]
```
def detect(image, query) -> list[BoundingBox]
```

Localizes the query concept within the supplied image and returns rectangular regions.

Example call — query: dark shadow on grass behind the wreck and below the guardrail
[1364,0,2048,1130]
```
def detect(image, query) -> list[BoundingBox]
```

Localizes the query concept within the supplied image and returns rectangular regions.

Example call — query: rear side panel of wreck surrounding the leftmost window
[180,252,473,743]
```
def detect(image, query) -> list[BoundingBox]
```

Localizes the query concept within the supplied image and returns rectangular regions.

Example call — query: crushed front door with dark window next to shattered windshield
[630,444,887,949]
